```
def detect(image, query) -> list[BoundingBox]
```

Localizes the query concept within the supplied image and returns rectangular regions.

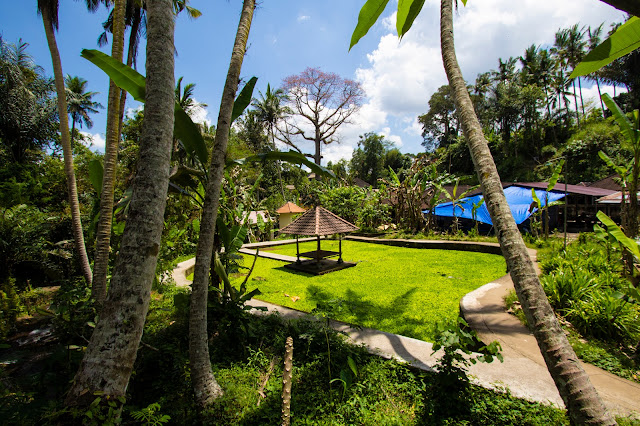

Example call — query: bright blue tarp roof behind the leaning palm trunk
[423,185,564,225]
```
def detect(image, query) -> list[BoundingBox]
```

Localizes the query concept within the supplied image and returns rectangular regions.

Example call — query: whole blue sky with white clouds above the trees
[0,0,624,165]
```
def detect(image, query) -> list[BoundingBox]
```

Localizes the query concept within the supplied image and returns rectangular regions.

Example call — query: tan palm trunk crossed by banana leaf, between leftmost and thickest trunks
[91,0,126,305]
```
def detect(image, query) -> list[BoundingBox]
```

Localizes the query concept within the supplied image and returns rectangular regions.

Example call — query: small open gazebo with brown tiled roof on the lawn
[280,206,358,275]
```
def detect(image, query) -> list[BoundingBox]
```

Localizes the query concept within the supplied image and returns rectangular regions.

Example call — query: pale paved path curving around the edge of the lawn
[173,237,640,418]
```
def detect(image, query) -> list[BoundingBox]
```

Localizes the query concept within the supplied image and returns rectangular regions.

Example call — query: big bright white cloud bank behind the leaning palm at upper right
[355,0,624,152]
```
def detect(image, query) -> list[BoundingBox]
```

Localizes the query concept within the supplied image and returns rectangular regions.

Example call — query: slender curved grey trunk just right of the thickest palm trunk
[189,0,255,407]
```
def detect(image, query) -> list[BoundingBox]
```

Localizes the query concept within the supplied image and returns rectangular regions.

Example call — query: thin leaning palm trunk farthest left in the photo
[41,8,92,284]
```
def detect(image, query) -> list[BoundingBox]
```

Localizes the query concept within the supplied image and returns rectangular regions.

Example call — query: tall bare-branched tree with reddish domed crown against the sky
[278,68,364,164]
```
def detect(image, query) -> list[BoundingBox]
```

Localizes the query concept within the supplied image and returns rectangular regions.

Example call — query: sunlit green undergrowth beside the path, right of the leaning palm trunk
[505,234,640,383]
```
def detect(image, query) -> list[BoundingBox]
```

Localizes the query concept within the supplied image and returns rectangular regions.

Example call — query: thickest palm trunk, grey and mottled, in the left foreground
[65,0,175,405]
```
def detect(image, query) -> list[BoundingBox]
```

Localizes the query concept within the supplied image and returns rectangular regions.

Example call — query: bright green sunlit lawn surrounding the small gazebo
[235,241,506,341]
